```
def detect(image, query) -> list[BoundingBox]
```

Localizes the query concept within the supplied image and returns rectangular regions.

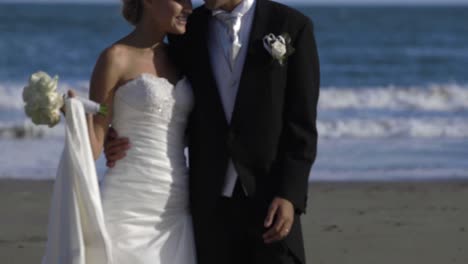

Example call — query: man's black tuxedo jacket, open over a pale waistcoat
[170,0,319,214]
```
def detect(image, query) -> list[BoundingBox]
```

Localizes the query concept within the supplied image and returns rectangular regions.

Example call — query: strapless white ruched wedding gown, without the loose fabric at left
[97,73,195,264]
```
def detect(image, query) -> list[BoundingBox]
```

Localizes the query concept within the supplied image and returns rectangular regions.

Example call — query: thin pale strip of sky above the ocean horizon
[0,0,468,5]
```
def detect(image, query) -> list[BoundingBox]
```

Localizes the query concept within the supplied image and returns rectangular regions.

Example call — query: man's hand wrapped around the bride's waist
[104,127,130,168]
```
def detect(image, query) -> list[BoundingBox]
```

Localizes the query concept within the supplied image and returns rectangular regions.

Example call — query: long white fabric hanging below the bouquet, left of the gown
[42,98,112,264]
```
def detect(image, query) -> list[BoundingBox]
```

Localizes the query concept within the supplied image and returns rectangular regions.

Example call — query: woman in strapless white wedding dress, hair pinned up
[43,0,195,264]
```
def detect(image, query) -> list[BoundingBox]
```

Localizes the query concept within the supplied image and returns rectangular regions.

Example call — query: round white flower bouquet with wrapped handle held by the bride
[23,71,107,127]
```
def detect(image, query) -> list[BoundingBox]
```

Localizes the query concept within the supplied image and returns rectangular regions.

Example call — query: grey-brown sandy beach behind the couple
[0,180,468,264]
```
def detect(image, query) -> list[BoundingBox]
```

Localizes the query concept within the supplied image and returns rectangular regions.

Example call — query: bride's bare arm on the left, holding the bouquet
[86,47,124,160]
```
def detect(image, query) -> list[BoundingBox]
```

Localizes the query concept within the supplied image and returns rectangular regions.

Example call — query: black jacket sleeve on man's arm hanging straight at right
[278,19,320,213]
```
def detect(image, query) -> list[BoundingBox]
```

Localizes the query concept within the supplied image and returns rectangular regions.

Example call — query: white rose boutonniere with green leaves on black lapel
[263,33,294,66]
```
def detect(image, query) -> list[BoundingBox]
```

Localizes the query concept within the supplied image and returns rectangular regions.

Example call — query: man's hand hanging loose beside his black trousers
[263,197,294,244]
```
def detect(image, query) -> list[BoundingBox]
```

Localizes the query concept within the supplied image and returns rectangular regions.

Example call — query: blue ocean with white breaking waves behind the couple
[0,4,468,181]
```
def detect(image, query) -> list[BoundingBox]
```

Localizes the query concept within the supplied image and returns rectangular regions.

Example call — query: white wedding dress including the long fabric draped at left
[43,73,196,264]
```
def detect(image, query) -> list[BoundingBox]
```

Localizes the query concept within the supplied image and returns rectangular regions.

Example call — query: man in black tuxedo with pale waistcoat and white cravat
[105,0,319,264]
